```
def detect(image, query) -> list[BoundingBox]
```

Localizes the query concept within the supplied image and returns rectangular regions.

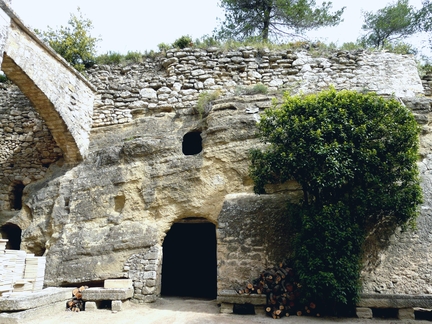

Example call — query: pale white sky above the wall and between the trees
[5,0,426,54]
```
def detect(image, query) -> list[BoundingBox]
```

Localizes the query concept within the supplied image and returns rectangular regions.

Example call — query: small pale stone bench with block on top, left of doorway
[82,279,134,311]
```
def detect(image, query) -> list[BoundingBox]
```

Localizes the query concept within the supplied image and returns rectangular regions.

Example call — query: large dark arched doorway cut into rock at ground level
[161,218,217,299]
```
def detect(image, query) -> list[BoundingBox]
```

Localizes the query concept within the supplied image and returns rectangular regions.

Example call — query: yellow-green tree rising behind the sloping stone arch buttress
[35,8,99,71]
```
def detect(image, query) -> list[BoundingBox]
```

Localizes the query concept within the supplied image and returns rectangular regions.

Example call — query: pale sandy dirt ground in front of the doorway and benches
[27,297,430,324]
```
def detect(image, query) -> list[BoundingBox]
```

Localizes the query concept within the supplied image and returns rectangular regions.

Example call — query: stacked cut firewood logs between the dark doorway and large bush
[238,264,320,319]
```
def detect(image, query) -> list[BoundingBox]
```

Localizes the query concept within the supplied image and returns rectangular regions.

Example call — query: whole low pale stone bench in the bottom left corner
[0,288,72,324]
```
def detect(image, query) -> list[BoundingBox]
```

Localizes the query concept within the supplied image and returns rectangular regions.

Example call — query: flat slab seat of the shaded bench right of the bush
[357,294,432,308]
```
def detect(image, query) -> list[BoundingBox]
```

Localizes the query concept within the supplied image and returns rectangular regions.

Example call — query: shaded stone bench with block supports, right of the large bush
[357,294,432,319]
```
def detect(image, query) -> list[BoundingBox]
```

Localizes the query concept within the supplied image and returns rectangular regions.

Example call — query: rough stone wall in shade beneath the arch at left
[0,84,62,211]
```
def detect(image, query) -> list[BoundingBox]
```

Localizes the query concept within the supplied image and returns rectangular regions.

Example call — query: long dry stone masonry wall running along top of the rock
[88,47,424,127]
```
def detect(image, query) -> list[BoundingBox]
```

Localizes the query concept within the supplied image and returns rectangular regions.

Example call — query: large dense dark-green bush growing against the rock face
[250,89,422,310]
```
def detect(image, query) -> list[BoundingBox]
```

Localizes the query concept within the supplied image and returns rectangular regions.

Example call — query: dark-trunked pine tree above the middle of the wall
[217,0,344,41]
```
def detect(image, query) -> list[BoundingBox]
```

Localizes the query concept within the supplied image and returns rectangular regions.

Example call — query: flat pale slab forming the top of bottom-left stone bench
[0,288,73,312]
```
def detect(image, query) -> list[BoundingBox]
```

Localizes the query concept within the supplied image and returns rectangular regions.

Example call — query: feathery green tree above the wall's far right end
[361,0,418,48]
